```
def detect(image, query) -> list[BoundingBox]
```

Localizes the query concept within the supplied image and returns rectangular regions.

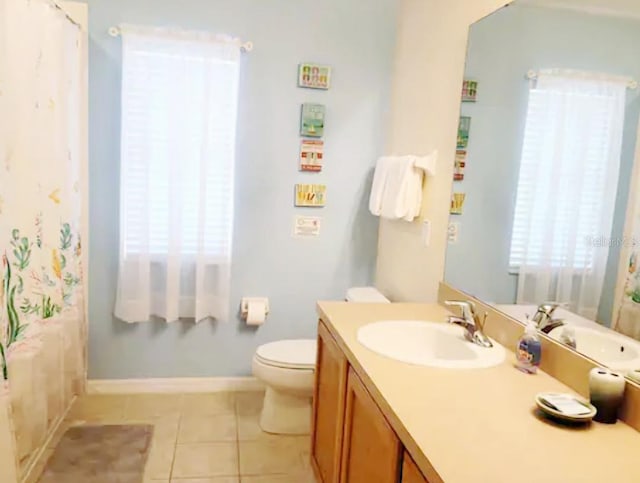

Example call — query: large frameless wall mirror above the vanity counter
[445,0,640,384]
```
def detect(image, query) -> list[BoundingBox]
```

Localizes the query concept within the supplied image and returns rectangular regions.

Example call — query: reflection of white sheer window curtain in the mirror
[510,70,628,320]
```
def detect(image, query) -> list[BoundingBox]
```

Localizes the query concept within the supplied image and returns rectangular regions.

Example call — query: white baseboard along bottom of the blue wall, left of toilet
[87,377,264,394]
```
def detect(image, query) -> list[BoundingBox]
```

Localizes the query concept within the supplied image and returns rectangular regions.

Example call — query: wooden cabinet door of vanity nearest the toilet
[311,322,348,483]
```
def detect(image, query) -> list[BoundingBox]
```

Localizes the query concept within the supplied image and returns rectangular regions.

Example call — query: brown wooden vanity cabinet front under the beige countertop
[311,322,428,483]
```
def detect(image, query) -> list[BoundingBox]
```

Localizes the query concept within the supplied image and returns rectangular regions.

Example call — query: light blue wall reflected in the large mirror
[445,3,640,324]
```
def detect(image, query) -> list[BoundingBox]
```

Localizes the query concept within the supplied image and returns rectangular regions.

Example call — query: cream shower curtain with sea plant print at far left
[0,0,87,482]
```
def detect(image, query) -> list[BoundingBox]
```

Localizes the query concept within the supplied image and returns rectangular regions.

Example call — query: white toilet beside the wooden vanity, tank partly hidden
[252,287,389,434]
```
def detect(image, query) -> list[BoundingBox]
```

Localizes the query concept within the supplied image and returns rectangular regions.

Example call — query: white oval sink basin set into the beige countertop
[358,320,505,369]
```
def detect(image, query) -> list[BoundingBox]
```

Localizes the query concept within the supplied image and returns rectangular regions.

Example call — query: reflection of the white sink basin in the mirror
[549,326,640,372]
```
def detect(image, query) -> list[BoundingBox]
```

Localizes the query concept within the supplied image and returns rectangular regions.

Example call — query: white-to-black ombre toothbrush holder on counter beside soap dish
[589,367,626,424]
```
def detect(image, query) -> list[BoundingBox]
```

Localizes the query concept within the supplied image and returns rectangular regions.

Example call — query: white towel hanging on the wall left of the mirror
[369,152,437,221]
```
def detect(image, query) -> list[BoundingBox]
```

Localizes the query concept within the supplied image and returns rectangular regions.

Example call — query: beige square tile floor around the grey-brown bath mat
[31,392,315,483]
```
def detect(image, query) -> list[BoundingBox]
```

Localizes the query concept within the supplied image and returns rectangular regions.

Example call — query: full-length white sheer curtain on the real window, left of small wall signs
[115,26,240,322]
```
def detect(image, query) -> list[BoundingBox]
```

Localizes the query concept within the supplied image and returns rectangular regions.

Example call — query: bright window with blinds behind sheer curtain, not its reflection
[121,29,238,258]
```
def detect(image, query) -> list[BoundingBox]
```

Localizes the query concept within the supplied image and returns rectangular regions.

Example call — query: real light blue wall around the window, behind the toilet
[88,0,397,379]
